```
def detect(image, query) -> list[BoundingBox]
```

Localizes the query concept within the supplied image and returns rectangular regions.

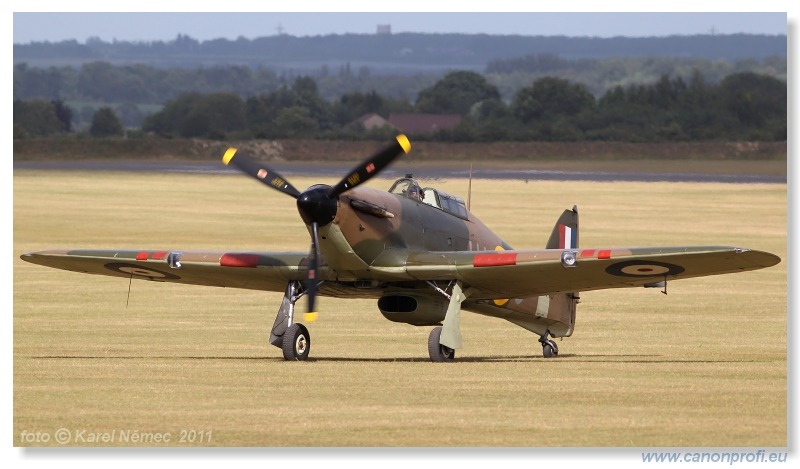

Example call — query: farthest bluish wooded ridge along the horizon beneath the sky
[13,33,787,68]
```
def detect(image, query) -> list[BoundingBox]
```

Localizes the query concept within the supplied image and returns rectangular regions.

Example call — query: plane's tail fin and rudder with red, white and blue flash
[545,206,580,337]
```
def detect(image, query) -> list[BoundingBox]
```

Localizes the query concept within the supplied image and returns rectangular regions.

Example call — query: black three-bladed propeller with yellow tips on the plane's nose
[222,134,411,322]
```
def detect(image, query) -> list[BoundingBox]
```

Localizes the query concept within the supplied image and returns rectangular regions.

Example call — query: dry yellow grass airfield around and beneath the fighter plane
[13,171,788,448]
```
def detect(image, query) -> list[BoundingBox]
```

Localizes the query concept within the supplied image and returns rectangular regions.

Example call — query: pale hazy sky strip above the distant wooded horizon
[13,10,787,43]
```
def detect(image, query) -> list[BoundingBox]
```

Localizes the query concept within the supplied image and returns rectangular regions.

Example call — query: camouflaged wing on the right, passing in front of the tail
[406,246,780,299]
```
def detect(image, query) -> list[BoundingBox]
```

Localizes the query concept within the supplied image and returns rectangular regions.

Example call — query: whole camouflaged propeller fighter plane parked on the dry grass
[22,135,780,362]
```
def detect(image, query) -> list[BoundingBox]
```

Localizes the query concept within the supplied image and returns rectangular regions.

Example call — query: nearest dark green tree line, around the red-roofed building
[14,71,787,142]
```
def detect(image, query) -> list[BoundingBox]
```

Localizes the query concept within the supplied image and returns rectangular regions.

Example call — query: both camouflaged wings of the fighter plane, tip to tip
[21,246,780,299]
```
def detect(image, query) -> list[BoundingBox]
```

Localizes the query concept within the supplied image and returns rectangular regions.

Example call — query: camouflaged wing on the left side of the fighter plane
[21,250,310,292]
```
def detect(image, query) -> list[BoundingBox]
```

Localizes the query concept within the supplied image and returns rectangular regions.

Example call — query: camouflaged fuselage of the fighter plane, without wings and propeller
[309,178,574,336]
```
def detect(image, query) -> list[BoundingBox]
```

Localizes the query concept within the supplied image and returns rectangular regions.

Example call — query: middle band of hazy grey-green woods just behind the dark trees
[13,53,787,104]
